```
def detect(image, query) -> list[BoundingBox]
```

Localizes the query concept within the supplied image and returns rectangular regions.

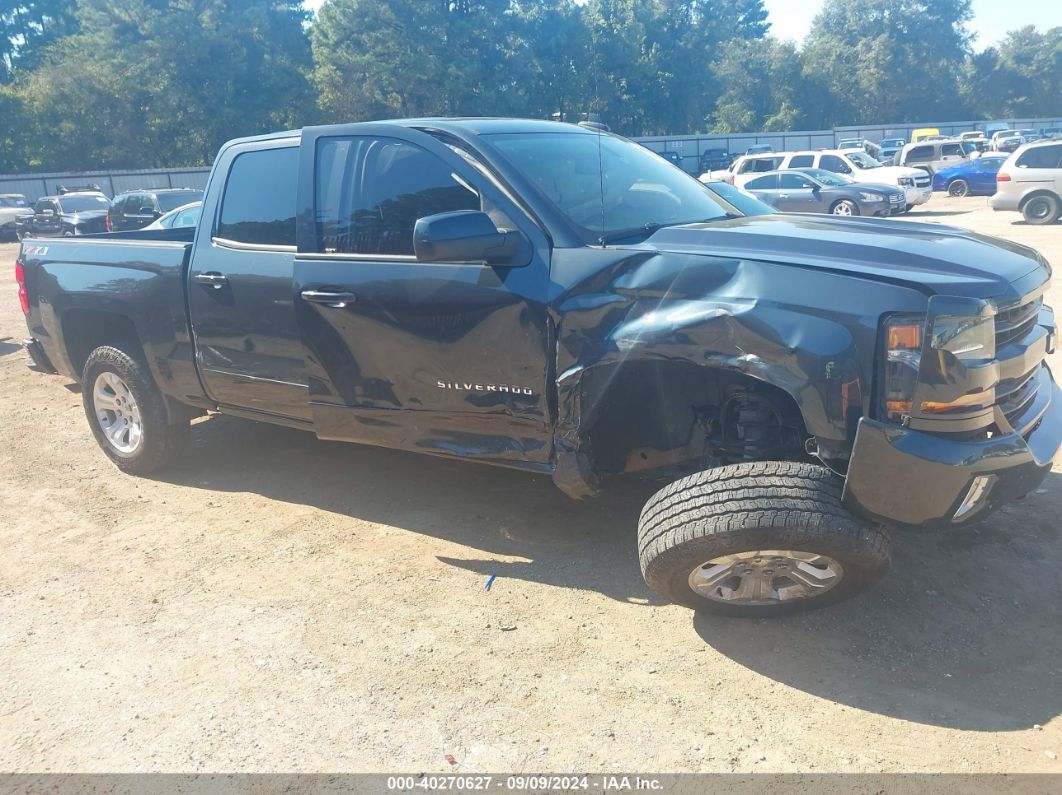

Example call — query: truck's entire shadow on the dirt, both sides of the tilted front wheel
[164,416,1062,731]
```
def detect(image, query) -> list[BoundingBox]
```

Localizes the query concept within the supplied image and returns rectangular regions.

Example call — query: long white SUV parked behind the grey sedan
[701,150,932,210]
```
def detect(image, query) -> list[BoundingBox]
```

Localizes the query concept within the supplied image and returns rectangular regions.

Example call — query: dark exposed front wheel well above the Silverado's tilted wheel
[583,361,807,474]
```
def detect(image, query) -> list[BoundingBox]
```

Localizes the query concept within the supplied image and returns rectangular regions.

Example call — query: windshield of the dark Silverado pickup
[487,132,729,242]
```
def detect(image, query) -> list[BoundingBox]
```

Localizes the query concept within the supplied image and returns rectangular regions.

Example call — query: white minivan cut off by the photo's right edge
[989,140,1062,224]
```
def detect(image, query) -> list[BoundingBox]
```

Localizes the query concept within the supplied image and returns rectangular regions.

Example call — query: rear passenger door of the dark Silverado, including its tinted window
[188,138,310,420]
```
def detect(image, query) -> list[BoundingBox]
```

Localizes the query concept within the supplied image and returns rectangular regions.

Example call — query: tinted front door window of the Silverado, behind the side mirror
[314,137,481,257]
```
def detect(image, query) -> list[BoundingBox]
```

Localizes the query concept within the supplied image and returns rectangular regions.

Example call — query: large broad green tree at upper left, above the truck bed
[18,0,312,169]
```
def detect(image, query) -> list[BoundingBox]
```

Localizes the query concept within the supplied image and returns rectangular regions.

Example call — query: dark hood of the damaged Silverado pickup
[641,214,1049,304]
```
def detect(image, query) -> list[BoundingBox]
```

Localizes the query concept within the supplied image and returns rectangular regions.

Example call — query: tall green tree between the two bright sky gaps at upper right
[804,0,972,126]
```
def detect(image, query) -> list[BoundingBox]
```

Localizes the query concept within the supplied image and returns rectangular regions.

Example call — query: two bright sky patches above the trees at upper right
[764,0,1062,50]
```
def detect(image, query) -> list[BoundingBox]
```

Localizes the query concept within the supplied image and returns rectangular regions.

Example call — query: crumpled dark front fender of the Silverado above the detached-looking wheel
[551,245,918,498]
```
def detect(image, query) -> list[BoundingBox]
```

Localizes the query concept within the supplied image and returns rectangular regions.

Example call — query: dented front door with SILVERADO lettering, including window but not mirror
[295,123,552,463]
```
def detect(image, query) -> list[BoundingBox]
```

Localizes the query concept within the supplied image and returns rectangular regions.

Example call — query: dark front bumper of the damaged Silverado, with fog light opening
[844,364,1062,526]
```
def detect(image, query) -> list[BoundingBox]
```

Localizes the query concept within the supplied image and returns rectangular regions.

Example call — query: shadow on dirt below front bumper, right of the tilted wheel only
[693,473,1062,731]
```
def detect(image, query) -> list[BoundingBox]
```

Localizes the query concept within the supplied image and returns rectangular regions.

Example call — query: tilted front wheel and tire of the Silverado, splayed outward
[638,462,889,617]
